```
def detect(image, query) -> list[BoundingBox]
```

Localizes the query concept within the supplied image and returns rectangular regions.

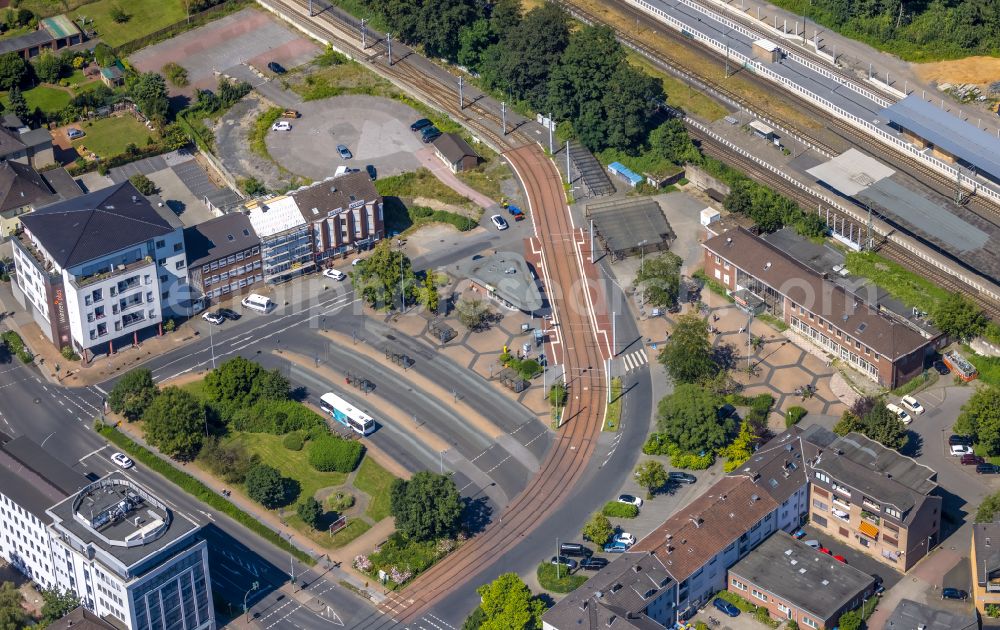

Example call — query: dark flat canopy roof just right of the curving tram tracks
[587,198,676,252]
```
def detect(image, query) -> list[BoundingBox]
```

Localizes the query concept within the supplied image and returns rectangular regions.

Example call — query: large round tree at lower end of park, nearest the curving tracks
[389,471,462,541]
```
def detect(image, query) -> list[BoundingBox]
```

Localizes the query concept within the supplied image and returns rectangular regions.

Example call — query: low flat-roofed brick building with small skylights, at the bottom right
[729,532,875,630]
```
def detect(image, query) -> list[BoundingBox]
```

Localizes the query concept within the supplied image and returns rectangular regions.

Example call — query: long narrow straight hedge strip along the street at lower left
[94,420,316,565]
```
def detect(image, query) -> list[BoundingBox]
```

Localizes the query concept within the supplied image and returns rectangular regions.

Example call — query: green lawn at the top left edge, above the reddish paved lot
[70,0,187,47]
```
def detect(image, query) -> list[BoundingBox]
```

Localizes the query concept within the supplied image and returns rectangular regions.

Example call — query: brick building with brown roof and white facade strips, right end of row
[291,172,385,265]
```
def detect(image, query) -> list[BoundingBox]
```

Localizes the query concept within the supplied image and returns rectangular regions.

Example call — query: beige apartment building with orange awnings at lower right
[803,426,942,572]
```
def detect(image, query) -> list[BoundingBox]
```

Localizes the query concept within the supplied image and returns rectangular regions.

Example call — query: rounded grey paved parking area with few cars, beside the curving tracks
[267,96,426,180]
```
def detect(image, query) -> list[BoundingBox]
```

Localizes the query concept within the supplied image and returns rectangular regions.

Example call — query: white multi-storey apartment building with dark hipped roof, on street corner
[12,181,190,358]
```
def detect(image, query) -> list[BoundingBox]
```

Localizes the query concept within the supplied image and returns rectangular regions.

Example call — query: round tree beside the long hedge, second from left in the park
[142,387,206,460]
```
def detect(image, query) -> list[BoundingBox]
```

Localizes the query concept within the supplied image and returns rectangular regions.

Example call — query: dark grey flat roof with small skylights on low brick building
[729,531,875,620]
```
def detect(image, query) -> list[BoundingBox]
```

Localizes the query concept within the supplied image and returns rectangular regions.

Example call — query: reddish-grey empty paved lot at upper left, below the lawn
[131,8,321,96]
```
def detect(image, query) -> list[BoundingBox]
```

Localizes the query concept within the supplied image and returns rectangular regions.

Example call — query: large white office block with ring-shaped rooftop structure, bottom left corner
[0,435,215,630]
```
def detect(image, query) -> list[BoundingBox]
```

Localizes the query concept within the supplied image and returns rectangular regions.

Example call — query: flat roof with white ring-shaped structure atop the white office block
[48,471,198,567]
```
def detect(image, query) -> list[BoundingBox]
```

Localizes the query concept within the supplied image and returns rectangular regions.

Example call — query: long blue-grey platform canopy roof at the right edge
[879,94,1000,181]
